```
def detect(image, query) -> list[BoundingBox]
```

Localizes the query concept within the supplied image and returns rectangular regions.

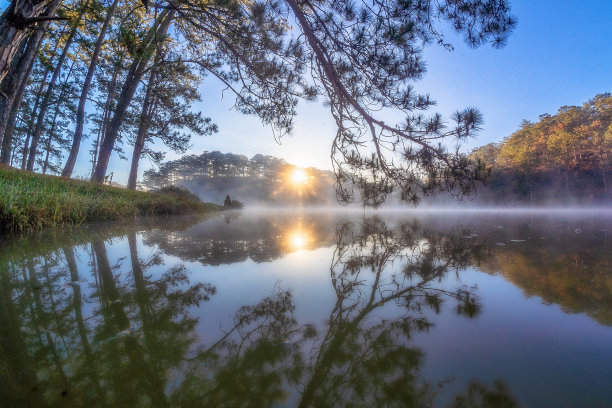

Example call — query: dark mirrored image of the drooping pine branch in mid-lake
[288,218,498,407]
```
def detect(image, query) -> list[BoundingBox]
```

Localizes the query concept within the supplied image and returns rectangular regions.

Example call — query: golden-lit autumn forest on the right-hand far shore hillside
[470,93,612,204]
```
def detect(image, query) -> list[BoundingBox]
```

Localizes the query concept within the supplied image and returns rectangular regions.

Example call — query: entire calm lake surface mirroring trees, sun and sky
[0,211,612,407]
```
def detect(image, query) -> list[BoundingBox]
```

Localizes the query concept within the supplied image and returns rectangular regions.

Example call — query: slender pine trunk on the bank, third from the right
[62,0,119,177]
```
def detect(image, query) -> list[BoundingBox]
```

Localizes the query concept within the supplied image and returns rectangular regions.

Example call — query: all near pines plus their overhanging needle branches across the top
[0,0,515,206]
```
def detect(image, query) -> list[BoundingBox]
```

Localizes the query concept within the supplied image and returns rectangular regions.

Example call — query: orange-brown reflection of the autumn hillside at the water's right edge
[479,223,612,325]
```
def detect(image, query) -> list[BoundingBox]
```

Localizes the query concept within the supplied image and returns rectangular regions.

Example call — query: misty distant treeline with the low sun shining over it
[143,151,336,205]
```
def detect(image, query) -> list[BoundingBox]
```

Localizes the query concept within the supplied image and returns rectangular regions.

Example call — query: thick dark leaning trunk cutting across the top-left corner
[0,0,60,83]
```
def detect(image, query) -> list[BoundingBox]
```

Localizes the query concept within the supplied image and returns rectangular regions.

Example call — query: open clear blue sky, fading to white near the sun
[67,0,612,182]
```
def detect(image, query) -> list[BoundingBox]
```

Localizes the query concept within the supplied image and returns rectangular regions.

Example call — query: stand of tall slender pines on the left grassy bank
[0,0,216,189]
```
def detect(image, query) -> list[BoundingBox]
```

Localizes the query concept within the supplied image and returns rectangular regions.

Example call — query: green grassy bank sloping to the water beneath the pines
[0,166,221,232]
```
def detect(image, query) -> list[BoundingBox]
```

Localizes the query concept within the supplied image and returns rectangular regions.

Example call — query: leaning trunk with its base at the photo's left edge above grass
[0,24,46,164]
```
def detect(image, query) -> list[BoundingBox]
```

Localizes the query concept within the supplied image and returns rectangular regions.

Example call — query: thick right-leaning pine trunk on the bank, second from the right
[92,10,175,183]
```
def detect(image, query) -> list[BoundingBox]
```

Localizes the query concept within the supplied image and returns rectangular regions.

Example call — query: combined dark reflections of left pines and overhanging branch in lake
[0,218,516,407]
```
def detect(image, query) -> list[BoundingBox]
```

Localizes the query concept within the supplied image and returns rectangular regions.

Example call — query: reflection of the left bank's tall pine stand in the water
[0,233,215,407]
